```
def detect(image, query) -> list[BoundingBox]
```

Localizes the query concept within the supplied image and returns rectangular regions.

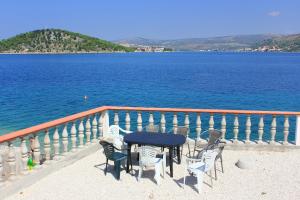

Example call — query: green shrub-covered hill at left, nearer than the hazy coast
[0,29,134,53]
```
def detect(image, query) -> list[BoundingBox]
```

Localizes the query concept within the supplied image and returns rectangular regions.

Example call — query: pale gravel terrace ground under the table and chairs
[7,150,300,200]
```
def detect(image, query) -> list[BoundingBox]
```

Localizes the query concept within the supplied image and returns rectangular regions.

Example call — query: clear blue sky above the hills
[0,0,300,40]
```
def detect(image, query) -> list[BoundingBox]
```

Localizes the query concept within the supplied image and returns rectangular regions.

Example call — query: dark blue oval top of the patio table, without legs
[124,132,186,146]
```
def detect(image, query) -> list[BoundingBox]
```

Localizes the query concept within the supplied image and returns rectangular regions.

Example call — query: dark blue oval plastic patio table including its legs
[124,132,186,177]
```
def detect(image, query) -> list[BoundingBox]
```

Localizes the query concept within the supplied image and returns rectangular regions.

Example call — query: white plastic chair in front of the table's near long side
[138,146,166,185]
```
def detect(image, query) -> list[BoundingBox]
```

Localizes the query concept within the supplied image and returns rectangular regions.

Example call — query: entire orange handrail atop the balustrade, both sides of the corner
[0,106,300,143]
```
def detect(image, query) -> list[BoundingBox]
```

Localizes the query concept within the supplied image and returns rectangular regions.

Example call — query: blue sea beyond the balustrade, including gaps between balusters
[0,52,300,140]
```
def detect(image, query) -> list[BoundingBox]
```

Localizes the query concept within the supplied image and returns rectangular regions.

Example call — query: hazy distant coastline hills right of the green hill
[114,34,300,52]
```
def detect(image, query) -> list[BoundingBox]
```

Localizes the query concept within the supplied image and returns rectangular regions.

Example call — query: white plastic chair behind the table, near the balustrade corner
[107,125,132,149]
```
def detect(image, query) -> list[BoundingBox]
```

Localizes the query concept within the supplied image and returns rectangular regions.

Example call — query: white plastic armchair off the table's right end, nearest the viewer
[183,150,218,193]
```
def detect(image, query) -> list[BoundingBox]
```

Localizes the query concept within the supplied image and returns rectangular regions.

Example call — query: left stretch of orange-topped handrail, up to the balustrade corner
[0,106,108,143]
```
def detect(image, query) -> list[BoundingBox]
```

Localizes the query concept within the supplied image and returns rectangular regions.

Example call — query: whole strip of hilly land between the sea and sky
[0,29,300,54]
